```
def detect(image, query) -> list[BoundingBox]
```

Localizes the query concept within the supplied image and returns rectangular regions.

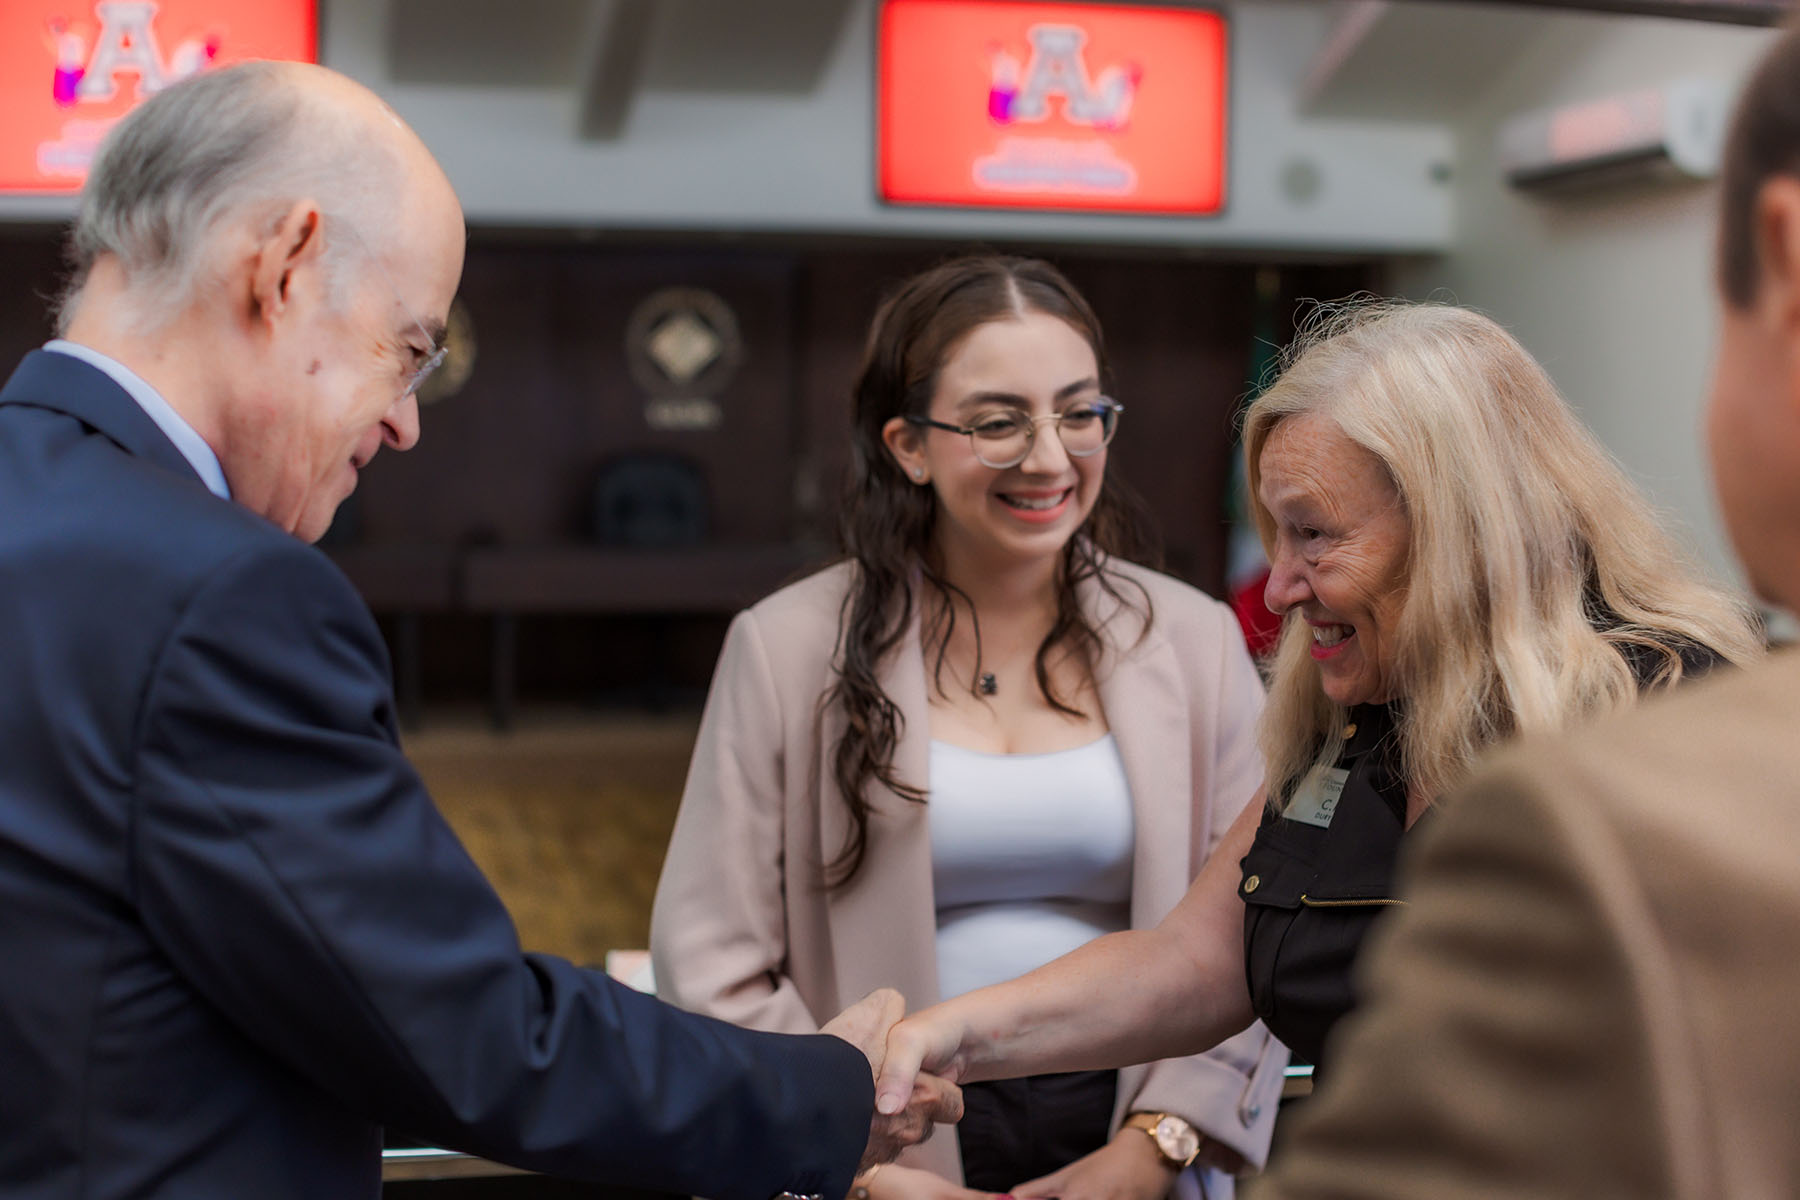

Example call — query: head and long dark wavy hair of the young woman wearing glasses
[832,255,1154,880]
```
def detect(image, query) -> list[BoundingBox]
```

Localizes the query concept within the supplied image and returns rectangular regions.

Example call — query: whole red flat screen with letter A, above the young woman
[877,0,1229,216]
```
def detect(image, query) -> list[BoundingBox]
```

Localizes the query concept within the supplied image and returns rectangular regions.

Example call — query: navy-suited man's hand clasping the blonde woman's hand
[819,988,963,1171]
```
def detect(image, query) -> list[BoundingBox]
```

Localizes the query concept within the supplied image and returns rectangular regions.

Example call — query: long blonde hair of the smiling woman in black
[1244,302,1762,808]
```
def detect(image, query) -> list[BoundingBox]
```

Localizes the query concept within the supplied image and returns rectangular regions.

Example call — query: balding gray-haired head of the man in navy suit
[59,63,464,540]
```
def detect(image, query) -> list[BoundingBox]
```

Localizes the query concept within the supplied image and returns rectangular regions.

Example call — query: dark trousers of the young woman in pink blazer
[956,1070,1120,1193]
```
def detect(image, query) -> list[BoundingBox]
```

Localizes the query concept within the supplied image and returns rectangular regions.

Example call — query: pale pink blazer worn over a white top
[650,563,1287,1180]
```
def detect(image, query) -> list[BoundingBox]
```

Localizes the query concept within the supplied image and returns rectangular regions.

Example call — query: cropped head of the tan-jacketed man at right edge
[1706,27,1800,608]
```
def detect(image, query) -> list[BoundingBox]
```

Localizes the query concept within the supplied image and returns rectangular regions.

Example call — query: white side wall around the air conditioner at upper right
[1395,14,1773,578]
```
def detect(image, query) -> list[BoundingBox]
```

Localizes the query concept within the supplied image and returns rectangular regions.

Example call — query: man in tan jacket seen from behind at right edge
[1258,31,1800,1200]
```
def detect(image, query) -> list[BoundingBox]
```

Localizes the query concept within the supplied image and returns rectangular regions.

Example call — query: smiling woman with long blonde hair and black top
[880,302,1760,1105]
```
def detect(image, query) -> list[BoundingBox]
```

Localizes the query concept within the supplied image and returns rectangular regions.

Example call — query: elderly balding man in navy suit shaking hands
[0,63,959,1200]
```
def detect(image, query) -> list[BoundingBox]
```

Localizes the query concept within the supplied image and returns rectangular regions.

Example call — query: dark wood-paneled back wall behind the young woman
[0,228,1379,703]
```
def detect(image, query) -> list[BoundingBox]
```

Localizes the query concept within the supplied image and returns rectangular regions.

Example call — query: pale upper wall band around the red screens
[0,0,1451,252]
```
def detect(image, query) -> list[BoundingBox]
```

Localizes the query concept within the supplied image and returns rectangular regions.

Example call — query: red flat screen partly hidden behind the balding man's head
[0,0,319,193]
